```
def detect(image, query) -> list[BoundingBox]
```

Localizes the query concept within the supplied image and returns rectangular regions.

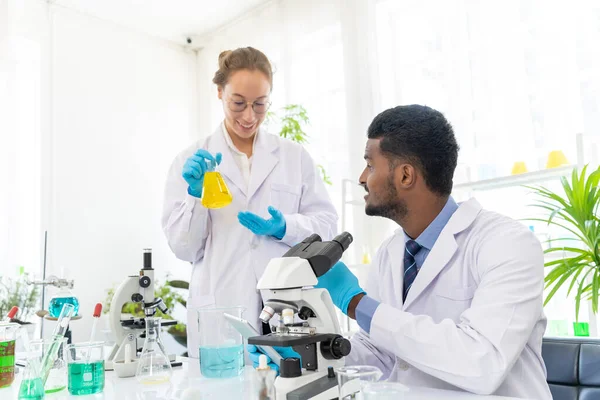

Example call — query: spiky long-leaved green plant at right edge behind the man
[527,165,600,336]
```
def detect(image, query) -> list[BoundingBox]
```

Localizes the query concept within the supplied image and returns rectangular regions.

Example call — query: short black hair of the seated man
[368,104,458,195]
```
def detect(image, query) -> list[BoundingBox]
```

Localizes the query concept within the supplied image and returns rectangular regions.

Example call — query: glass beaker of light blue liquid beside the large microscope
[196,307,245,378]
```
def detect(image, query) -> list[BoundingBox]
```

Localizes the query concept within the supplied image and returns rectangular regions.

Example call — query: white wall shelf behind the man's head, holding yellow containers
[452,165,575,190]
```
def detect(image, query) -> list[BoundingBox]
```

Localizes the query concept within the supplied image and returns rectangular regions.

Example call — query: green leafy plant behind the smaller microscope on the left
[103,277,189,347]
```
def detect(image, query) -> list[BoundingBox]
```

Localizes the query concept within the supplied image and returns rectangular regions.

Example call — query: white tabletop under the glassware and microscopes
[0,358,514,400]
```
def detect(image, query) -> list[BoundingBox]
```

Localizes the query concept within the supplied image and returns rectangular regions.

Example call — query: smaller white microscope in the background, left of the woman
[105,249,177,370]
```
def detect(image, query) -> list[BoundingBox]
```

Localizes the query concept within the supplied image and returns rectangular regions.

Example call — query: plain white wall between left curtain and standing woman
[45,8,196,340]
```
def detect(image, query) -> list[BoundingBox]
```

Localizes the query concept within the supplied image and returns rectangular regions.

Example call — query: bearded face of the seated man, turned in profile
[359,139,412,220]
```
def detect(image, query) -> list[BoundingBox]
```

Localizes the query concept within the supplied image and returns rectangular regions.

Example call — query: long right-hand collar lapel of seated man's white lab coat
[400,198,482,310]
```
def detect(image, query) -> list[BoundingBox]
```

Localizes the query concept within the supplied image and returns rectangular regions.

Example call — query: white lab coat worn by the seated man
[346,199,552,400]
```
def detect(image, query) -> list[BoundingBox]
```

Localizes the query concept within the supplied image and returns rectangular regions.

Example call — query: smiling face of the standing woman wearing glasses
[218,69,271,141]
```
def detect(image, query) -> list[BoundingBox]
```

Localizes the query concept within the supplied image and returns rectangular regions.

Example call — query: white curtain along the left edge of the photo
[0,0,47,276]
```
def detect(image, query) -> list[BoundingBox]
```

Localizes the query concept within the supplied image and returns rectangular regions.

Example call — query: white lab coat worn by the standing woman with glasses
[162,127,337,357]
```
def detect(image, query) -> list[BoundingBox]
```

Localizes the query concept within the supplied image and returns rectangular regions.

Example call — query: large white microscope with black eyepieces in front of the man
[248,232,352,400]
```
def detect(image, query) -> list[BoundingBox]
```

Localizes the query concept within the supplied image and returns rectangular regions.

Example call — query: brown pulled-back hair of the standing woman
[213,47,273,88]
